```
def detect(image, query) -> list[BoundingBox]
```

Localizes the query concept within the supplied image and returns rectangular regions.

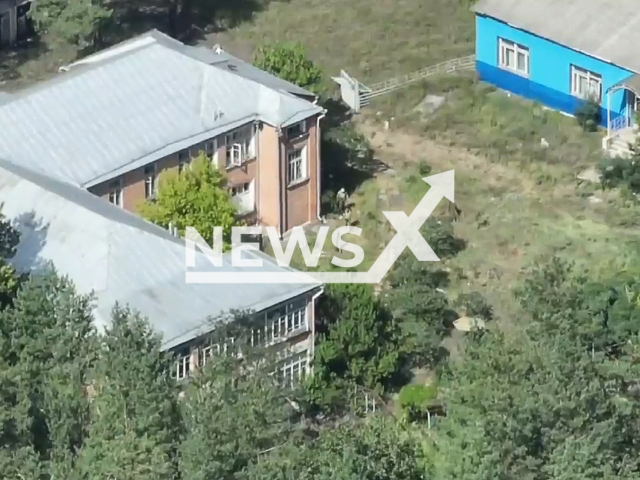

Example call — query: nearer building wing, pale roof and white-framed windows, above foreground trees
[0,159,322,384]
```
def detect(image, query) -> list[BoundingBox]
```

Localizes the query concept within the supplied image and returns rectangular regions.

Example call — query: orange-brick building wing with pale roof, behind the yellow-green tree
[0,31,324,235]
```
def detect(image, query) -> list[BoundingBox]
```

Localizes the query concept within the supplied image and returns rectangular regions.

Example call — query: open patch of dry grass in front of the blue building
[361,90,640,325]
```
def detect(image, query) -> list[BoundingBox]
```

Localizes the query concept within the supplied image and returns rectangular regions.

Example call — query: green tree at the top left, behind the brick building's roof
[32,0,113,48]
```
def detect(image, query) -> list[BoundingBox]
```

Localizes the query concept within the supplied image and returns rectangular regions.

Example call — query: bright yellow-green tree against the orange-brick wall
[139,153,238,243]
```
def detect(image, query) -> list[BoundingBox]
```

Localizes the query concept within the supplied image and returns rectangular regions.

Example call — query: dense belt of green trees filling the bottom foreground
[5,205,640,480]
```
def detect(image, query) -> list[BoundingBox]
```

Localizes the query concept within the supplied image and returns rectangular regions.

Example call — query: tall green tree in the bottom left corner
[0,272,97,478]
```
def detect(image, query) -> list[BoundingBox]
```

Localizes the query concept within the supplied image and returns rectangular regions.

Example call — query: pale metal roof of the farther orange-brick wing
[0,32,322,187]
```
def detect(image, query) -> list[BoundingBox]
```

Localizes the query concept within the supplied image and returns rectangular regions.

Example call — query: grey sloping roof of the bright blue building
[474,0,640,73]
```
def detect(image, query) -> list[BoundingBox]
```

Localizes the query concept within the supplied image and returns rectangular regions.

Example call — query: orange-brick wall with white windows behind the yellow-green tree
[89,114,320,233]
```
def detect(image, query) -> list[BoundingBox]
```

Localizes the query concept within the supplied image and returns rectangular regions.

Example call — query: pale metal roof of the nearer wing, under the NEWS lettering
[0,160,320,349]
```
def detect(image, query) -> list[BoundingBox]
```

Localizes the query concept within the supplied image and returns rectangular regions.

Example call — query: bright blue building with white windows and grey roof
[474,0,640,153]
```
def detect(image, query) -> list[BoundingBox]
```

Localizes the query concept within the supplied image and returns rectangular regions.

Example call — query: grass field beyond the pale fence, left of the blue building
[207,0,474,82]
